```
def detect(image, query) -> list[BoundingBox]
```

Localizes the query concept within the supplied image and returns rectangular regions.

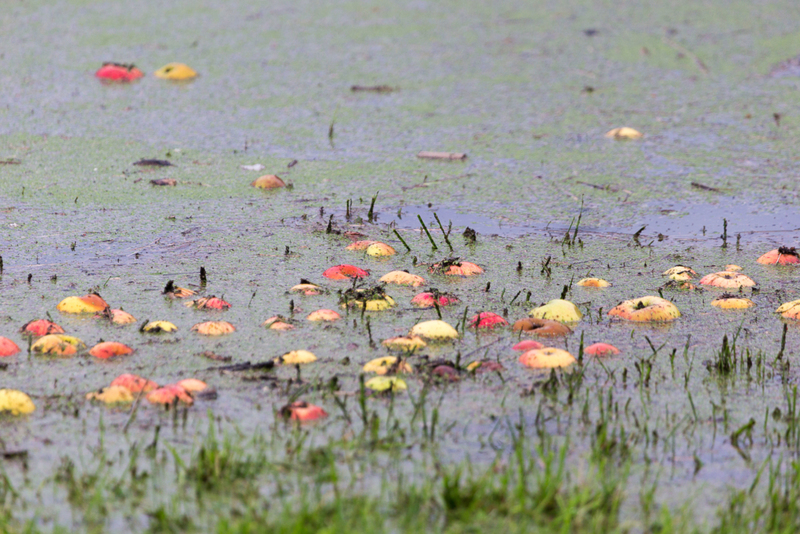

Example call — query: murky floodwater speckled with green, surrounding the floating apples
[0,0,800,530]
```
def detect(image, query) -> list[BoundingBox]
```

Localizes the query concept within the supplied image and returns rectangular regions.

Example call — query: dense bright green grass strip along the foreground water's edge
[7,414,800,534]
